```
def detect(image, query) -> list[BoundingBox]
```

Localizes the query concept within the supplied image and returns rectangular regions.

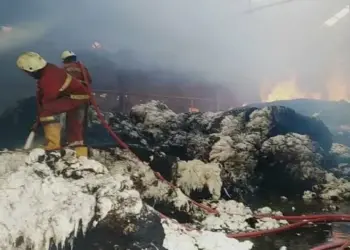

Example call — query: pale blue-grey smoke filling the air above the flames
[0,0,349,105]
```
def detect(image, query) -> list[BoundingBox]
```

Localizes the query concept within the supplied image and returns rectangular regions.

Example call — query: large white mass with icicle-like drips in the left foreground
[0,149,143,250]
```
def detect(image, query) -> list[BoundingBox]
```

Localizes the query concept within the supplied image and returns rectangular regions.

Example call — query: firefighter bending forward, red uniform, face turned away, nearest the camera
[17,52,90,156]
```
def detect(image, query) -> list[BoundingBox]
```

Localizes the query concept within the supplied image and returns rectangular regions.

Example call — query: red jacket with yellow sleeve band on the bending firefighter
[37,63,89,121]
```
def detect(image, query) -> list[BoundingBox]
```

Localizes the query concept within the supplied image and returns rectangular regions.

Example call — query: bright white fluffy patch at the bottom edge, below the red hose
[162,219,253,250]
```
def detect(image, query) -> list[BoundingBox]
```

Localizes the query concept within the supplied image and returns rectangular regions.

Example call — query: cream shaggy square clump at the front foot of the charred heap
[177,160,222,199]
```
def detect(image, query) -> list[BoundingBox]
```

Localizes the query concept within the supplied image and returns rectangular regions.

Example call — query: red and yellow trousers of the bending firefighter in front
[40,98,88,156]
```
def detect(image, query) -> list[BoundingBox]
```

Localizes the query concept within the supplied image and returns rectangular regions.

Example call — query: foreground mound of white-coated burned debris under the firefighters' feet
[0,148,266,250]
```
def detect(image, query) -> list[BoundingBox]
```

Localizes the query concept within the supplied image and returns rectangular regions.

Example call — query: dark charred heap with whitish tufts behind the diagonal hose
[87,101,346,200]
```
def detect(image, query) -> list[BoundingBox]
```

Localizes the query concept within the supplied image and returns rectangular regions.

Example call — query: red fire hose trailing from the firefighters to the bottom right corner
[80,61,350,250]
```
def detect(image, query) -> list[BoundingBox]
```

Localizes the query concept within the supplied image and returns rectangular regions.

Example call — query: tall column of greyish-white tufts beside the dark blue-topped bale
[209,108,271,183]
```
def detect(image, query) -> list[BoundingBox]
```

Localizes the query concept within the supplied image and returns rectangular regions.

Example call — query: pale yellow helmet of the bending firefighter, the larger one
[17,52,47,72]
